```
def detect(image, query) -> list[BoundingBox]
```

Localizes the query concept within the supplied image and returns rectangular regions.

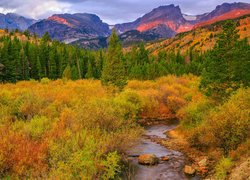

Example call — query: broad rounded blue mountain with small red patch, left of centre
[29,13,110,43]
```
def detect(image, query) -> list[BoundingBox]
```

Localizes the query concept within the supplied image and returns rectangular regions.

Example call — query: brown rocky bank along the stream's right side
[139,118,215,179]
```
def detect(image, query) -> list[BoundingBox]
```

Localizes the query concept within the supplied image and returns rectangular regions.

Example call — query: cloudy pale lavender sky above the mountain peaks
[0,0,250,24]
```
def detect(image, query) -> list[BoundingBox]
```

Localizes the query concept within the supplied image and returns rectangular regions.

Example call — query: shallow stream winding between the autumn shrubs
[128,124,199,180]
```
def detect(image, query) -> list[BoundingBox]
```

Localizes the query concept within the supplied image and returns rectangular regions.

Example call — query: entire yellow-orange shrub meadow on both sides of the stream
[0,75,250,179]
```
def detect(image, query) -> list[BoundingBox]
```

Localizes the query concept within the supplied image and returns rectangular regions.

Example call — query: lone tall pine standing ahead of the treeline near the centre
[101,30,127,88]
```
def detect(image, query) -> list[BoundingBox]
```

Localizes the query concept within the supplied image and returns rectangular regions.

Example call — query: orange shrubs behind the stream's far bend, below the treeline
[126,75,199,119]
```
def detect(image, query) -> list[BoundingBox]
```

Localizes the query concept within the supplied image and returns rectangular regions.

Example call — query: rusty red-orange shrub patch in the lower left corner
[0,128,48,177]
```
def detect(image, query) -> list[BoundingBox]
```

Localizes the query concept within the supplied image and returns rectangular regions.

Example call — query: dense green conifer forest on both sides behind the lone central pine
[0,29,204,82]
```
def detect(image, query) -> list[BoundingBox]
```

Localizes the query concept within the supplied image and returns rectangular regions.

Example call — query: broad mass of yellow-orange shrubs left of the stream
[0,79,142,179]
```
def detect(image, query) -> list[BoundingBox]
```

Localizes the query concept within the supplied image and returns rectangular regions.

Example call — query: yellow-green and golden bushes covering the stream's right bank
[179,88,250,156]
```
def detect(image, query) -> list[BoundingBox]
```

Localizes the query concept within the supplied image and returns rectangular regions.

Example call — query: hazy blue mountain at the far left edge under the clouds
[0,13,36,31]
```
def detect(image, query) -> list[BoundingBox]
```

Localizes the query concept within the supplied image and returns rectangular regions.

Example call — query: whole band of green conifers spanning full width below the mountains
[0,20,250,94]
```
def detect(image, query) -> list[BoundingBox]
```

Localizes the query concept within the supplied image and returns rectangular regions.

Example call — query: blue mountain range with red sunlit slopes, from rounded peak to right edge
[22,3,250,49]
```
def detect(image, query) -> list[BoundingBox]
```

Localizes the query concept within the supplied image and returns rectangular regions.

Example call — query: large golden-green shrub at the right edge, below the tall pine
[207,88,250,155]
